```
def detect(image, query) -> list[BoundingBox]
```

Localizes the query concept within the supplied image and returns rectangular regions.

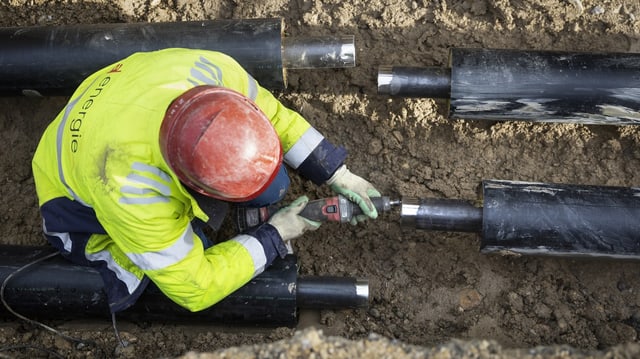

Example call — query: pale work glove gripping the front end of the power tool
[327,165,381,225]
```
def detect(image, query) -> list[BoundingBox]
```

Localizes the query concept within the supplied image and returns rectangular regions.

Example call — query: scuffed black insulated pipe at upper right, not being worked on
[378,48,640,125]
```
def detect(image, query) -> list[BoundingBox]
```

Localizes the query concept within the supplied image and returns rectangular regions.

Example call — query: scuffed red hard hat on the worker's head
[160,86,282,202]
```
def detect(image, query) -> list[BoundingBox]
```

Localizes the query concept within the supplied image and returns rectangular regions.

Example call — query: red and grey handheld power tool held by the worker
[235,195,400,232]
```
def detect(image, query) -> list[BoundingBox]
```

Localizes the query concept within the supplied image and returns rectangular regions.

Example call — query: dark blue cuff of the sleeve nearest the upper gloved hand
[298,139,347,185]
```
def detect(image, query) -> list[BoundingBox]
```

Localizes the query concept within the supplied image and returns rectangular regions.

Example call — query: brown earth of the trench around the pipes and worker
[0,0,640,358]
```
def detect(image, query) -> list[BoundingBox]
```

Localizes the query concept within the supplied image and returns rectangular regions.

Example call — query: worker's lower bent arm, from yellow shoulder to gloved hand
[93,151,317,311]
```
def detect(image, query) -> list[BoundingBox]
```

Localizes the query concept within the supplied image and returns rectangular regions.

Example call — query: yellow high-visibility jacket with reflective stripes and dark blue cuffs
[32,49,346,312]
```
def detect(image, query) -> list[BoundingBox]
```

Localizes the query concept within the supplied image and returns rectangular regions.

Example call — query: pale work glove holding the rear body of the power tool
[268,196,321,253]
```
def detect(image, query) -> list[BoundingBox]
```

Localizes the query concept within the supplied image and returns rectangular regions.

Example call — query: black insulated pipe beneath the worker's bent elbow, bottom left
[0,245,369,326]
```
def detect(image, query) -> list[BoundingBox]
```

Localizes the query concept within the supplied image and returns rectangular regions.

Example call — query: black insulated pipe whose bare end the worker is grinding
[400,180,640,259]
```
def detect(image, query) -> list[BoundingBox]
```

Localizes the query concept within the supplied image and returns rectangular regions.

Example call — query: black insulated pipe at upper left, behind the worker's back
[0,18,355,96]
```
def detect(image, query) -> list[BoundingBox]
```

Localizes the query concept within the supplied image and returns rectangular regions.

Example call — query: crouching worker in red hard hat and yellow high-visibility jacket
[32,48,380,313]
